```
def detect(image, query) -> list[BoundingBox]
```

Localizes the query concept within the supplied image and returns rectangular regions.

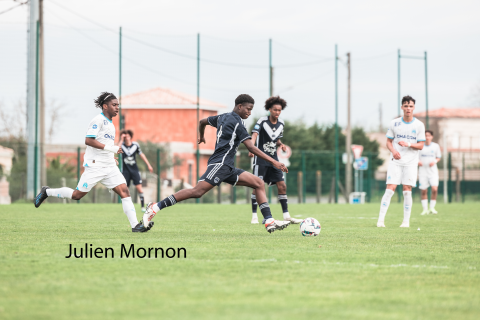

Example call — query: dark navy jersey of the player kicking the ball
[207,112,252,168]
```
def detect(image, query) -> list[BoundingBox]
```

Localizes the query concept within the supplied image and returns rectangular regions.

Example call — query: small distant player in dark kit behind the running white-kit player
[120,129,153,212]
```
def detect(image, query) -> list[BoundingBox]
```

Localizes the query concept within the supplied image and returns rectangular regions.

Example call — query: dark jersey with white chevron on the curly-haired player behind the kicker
[252,117,285,167]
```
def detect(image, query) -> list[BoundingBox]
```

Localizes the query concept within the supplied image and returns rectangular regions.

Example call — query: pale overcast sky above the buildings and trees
[0,0,480,144]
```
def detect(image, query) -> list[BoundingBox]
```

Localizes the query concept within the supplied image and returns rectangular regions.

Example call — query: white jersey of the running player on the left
[83,112,117,167]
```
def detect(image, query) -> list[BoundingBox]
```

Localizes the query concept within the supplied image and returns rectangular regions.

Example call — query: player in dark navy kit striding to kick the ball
[143,94,290,233]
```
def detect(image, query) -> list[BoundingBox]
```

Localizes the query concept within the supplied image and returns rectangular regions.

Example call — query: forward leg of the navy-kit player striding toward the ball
[234,169,290,233]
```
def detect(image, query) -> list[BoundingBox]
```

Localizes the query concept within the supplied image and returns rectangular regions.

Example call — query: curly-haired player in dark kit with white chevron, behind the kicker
[248,96,302,224]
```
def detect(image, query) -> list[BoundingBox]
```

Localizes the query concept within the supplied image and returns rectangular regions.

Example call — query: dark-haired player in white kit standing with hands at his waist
[377,96,425,228]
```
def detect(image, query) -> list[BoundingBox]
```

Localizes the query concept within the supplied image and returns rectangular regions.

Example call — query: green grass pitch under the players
[0,203,480,320]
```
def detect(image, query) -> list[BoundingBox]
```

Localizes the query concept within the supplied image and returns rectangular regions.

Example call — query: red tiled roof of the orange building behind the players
[122,87,226,108]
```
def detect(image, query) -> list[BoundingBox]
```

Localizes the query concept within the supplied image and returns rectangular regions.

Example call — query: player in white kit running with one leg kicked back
[35,92,153,232]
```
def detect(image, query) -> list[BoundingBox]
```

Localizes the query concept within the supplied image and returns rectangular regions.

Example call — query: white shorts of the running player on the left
[77,166,127,192]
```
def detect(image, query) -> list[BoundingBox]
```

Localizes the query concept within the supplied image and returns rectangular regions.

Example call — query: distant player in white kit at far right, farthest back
[418,130,442,216]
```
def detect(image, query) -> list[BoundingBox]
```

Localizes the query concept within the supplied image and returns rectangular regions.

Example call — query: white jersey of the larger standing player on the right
[387,117,425,166]
